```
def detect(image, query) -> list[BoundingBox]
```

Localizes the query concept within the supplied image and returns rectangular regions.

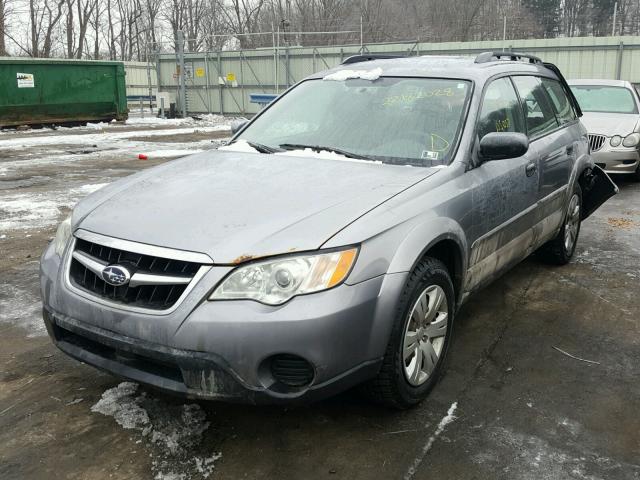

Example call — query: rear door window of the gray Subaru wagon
[513,76,559,138]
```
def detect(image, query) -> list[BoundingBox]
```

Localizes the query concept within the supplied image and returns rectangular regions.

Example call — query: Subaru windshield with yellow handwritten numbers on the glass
[237,78,471,166]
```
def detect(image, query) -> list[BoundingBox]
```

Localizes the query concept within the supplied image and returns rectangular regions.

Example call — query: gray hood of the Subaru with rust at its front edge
[74,151,437,264]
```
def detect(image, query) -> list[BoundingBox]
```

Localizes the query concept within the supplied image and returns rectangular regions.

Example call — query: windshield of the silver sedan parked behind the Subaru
[571,85,638,113]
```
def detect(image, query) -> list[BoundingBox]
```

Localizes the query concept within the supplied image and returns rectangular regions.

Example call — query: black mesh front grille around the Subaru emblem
[69,238,202,310]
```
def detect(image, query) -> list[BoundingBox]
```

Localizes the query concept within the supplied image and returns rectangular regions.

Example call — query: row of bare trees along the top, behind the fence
[0,0,640,60]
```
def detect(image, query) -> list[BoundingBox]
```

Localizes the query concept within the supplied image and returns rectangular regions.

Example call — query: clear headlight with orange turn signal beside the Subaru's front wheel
[209,248,358,305]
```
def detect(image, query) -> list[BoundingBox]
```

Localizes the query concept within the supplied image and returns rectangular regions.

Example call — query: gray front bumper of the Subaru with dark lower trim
[41,242,406,403]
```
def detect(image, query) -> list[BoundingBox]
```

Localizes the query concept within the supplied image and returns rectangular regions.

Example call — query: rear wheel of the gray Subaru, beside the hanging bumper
[540,182,582,265]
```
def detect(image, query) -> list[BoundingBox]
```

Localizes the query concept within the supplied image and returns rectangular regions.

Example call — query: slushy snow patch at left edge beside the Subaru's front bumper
[0,261,47,337]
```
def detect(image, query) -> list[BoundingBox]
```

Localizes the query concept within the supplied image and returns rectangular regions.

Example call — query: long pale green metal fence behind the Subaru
[149,36,640,115]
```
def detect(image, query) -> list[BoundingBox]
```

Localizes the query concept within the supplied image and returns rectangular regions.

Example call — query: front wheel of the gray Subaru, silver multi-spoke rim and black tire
[362,257,455,409]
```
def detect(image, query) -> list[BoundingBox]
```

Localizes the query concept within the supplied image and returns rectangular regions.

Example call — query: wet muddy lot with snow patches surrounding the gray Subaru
[0,125,640,480]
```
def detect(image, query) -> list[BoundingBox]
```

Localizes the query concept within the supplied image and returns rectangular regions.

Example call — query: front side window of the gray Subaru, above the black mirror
[478,78,525,138]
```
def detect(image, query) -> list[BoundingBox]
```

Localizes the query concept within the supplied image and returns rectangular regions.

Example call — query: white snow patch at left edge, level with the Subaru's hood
[0,183,108,233]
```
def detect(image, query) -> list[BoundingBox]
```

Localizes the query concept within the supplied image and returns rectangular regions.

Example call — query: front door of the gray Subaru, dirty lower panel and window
[465,77,538,291]
